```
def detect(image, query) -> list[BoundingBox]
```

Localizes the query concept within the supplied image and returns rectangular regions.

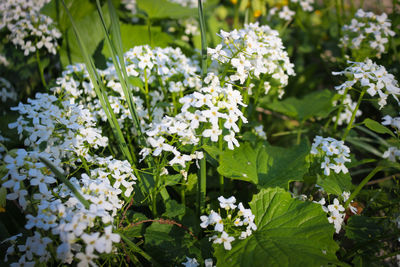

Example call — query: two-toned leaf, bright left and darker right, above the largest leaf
[218,142,310,189]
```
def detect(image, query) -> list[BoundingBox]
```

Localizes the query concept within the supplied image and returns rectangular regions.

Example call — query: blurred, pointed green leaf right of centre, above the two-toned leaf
[261,90,335,121]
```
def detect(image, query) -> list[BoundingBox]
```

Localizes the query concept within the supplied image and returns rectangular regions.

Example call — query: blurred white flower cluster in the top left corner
[0,0,61,56]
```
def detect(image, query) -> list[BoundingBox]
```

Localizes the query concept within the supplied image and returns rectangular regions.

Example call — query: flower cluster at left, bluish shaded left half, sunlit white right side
[9,93,108,161]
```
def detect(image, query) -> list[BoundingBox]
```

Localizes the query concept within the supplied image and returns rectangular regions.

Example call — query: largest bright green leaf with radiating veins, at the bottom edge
[215,188,340,267]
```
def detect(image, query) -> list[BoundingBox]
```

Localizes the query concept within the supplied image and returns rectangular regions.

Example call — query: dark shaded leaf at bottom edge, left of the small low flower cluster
[144,222,200,266]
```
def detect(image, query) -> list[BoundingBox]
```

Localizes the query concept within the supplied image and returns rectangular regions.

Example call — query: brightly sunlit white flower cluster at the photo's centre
[140,73,247,167]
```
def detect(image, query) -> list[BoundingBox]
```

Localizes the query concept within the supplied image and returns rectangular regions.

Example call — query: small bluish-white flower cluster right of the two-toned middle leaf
[310,135,351,176]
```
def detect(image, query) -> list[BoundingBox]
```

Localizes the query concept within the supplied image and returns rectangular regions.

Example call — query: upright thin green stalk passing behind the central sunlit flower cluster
[198,0,207,214]
